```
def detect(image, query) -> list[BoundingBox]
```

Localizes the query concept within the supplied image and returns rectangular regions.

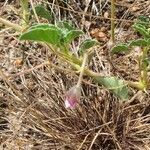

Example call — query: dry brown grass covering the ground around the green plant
[0,1,150,150]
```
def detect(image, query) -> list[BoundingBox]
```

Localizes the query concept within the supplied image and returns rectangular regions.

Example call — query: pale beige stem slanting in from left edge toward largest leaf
[0,18,22,31]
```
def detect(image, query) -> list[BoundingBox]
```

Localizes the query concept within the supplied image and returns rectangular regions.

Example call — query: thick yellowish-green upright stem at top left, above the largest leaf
[20,0,29,27]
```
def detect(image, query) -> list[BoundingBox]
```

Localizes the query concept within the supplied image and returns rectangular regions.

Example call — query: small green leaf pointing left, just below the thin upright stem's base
[111,44,129,54]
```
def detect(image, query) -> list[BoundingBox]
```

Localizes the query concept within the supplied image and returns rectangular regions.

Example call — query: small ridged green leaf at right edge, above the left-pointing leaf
[133,23,150,38]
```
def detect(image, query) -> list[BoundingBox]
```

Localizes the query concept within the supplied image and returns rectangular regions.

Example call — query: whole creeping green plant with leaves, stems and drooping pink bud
[0,1,150,108]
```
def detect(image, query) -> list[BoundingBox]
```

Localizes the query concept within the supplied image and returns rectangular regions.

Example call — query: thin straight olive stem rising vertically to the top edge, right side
[111,0,115,43]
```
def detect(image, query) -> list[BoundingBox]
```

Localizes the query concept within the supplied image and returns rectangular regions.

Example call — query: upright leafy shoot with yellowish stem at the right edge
[111,16,150,90]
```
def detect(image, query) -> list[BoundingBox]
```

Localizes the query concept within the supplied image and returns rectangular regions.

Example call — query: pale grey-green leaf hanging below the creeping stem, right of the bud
[95,77,129,100]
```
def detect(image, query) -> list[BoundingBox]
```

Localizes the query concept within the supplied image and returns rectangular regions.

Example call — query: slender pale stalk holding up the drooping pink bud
[77,53,88,87]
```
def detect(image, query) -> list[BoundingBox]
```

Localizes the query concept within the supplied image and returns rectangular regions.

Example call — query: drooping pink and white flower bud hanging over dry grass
[65,86,81,108]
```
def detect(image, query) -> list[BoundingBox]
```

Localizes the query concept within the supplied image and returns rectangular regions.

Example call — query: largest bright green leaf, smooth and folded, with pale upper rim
[20,24,62,45]
